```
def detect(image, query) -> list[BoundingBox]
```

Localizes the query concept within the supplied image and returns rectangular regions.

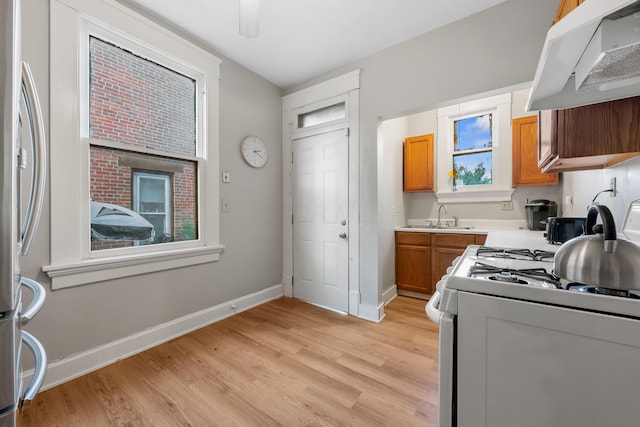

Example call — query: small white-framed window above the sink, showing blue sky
[436,93,513,203]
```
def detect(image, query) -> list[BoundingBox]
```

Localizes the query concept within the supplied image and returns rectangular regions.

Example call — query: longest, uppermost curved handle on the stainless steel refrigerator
[21,62,47,255]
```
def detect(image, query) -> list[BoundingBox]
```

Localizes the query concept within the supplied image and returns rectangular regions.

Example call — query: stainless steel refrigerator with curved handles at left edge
[0,0,47,427]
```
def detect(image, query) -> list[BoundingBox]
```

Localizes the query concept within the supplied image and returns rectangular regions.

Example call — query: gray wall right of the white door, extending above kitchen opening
[287,0,558,305]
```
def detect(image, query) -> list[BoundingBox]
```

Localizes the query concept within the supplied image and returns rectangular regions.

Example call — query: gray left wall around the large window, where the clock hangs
[22,0,282,361]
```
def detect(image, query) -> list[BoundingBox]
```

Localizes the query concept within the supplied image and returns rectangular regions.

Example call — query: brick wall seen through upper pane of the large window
[89,38,196,155]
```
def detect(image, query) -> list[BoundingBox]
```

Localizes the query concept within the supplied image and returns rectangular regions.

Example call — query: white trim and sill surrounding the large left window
[43,0,224,289]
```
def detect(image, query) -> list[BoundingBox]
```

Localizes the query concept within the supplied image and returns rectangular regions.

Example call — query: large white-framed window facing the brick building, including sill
[44,0,222,289]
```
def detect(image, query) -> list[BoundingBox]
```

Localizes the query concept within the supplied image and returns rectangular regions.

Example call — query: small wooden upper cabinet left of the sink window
[402,133,434,193]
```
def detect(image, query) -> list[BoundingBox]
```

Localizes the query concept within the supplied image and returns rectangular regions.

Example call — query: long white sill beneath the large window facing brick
[42,245,224,290]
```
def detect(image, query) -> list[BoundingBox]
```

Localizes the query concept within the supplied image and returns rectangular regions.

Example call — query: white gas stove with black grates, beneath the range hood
[427,239,640,427]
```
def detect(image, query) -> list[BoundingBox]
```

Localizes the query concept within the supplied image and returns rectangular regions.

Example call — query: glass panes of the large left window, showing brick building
[88,35,198,251]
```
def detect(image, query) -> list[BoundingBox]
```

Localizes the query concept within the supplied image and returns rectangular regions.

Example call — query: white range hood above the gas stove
[526,0,640,111]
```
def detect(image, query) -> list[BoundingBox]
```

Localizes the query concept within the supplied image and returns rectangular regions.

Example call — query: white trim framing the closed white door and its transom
[282,70,361,316]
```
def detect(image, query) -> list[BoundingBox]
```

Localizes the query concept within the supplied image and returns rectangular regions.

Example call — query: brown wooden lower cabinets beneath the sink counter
[396,231,486,296]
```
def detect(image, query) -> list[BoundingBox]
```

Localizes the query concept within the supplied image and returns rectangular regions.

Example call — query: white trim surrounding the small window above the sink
[435,93,514,203]
